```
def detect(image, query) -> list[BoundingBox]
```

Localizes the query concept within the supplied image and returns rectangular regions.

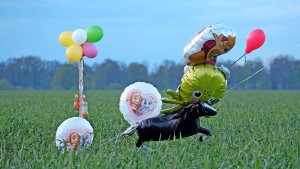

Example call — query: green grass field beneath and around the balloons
[0,91,300,169]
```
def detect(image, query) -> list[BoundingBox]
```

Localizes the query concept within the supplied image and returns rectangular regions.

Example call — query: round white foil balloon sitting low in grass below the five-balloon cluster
[55,117,94,153]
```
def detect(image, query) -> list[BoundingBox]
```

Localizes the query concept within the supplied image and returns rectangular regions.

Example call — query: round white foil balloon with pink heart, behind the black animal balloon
[119,82,162,126]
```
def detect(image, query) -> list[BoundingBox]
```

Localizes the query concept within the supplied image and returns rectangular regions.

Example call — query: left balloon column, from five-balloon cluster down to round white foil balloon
[56,26,103,154]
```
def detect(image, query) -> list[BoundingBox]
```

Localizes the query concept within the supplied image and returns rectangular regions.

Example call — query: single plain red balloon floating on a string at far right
[245,29,266,54]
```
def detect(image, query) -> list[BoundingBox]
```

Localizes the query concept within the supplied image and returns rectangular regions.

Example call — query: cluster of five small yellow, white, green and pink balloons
[59,26,103,62]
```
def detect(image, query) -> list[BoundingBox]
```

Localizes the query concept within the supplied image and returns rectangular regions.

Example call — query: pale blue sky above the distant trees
[0,0,300,67]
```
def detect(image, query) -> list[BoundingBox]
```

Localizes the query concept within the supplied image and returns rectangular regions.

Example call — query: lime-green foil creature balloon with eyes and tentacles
[162,64,227,114]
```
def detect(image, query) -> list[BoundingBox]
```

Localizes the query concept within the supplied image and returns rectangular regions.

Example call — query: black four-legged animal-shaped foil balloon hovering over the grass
[122,102,217,147]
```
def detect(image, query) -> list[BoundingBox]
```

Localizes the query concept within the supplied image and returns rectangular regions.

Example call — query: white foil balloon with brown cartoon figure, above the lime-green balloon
[183,24,236,66]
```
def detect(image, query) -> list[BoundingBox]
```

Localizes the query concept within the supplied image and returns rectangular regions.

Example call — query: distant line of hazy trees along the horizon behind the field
[0,55,300,90]
